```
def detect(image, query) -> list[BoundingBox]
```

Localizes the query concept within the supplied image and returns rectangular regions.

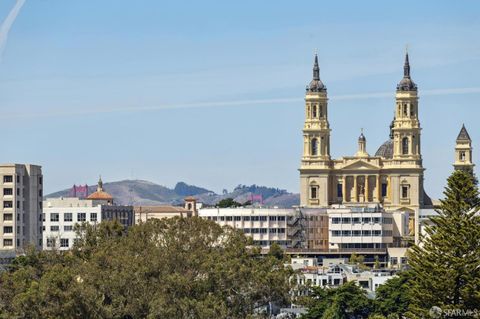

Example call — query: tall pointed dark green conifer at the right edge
[409,170,480,317]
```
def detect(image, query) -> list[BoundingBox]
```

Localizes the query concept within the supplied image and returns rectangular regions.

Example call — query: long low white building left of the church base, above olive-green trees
[198,207,295,248]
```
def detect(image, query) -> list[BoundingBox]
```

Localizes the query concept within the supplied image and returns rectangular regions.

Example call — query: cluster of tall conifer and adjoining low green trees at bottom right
[304,171,480,319]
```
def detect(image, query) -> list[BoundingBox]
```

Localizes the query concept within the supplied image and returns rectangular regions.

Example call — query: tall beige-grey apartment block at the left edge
[0,164,43,252]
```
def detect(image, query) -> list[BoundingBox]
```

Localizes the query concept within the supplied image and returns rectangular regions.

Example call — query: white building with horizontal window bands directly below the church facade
[328,207,394,252]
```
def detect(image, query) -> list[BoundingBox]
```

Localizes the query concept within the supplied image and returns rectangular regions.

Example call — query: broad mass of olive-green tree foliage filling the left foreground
[0,217,291,319]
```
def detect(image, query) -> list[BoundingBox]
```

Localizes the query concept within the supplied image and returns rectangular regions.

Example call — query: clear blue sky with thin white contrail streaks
[0,0,480,197]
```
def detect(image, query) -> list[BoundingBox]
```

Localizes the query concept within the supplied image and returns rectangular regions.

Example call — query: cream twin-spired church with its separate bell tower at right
[299,52,473,242]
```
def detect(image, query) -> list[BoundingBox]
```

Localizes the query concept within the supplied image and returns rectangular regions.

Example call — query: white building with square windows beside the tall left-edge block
[43,197,102,250]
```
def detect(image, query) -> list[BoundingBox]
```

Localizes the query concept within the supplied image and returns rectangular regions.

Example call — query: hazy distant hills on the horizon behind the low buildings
[46,180,300,207]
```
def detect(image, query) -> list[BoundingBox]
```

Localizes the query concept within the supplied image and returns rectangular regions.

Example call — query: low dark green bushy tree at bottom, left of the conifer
[303,282,373,319]
